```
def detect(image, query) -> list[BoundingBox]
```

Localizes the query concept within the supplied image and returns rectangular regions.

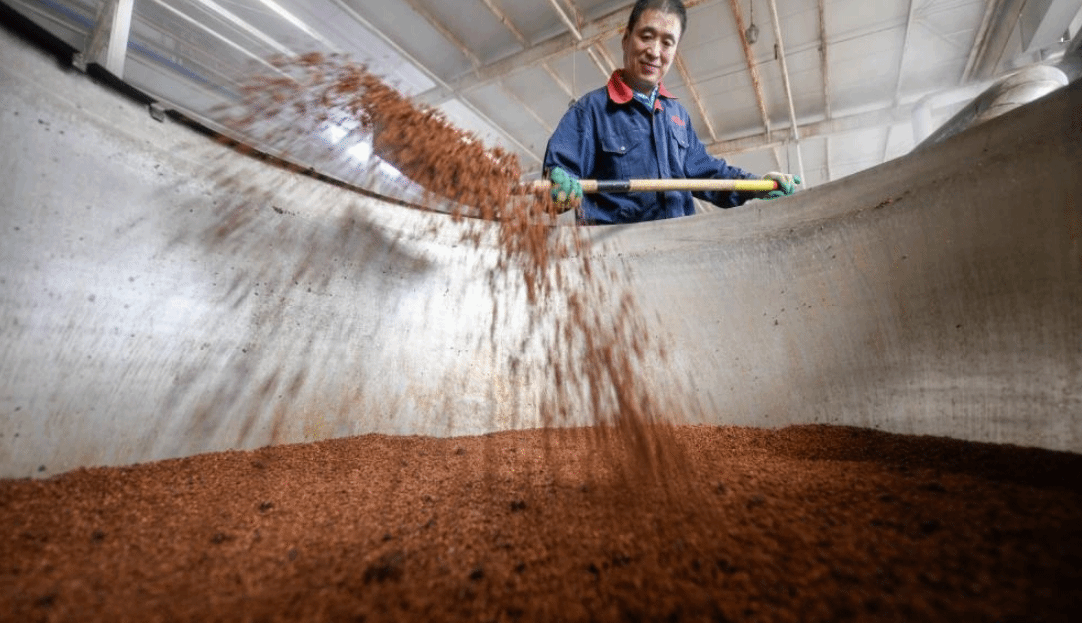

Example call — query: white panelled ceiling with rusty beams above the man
[3,0,1082,194]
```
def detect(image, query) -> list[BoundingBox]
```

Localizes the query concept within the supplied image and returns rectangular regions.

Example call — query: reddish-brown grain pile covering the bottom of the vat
[6,426,1082,623]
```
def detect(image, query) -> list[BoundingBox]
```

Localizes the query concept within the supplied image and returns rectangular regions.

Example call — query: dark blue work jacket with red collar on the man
[544,69,758,224]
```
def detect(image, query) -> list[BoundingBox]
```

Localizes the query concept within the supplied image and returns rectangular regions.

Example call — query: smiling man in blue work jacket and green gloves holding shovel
[544,0,801,225]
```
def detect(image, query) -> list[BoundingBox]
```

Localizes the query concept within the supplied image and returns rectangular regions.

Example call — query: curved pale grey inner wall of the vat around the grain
[0,25,1082,477]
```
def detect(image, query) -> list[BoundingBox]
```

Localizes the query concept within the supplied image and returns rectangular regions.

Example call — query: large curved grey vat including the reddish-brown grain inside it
[0,21,1082,621]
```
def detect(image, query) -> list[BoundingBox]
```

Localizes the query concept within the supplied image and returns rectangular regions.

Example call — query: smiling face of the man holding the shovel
[623,9,681,93]
